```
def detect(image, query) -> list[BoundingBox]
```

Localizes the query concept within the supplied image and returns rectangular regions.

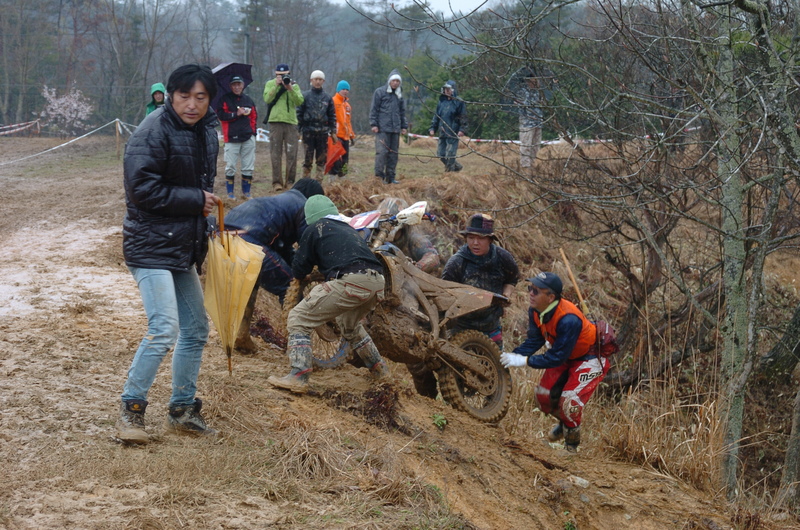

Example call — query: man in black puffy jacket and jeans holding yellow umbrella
[117,64,220,443]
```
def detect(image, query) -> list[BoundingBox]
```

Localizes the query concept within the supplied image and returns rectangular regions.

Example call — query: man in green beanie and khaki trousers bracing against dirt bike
[267,195,389,393]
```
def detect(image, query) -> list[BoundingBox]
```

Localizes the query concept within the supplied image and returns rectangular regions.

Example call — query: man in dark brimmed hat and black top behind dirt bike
[442,213,520,350]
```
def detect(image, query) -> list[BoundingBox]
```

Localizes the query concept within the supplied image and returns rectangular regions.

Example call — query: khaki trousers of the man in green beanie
[286,271,385,368]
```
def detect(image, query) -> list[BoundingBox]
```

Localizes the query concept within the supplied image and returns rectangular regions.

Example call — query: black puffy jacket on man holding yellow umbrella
[122,99,219,272]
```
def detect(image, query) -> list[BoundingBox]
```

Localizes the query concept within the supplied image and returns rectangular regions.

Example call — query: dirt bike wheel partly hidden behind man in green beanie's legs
[282,275,353,370]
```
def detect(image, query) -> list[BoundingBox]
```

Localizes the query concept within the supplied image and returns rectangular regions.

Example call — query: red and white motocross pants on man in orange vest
[535,356,610,429]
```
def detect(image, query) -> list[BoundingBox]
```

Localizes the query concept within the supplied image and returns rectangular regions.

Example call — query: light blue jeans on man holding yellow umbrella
[122,267,208,406]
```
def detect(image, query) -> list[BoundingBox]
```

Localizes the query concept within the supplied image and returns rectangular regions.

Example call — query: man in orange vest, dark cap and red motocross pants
[500,272,609,453]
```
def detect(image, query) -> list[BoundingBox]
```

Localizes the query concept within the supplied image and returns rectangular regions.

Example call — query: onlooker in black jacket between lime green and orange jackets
[297,70,338,180]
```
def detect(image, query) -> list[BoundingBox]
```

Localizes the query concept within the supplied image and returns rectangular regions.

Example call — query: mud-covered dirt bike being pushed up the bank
[284,201,512,422]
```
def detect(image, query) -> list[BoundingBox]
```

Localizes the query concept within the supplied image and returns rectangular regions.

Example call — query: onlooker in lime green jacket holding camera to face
[264,63,303,191]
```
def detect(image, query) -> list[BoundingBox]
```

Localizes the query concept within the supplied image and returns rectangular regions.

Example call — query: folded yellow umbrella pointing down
[204,202,264,374]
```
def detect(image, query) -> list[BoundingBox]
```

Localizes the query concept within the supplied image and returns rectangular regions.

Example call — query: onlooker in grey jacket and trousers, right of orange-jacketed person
[369,70,408,184]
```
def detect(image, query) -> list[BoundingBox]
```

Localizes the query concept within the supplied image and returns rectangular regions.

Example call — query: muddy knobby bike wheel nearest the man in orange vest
[437,330,512,423]
